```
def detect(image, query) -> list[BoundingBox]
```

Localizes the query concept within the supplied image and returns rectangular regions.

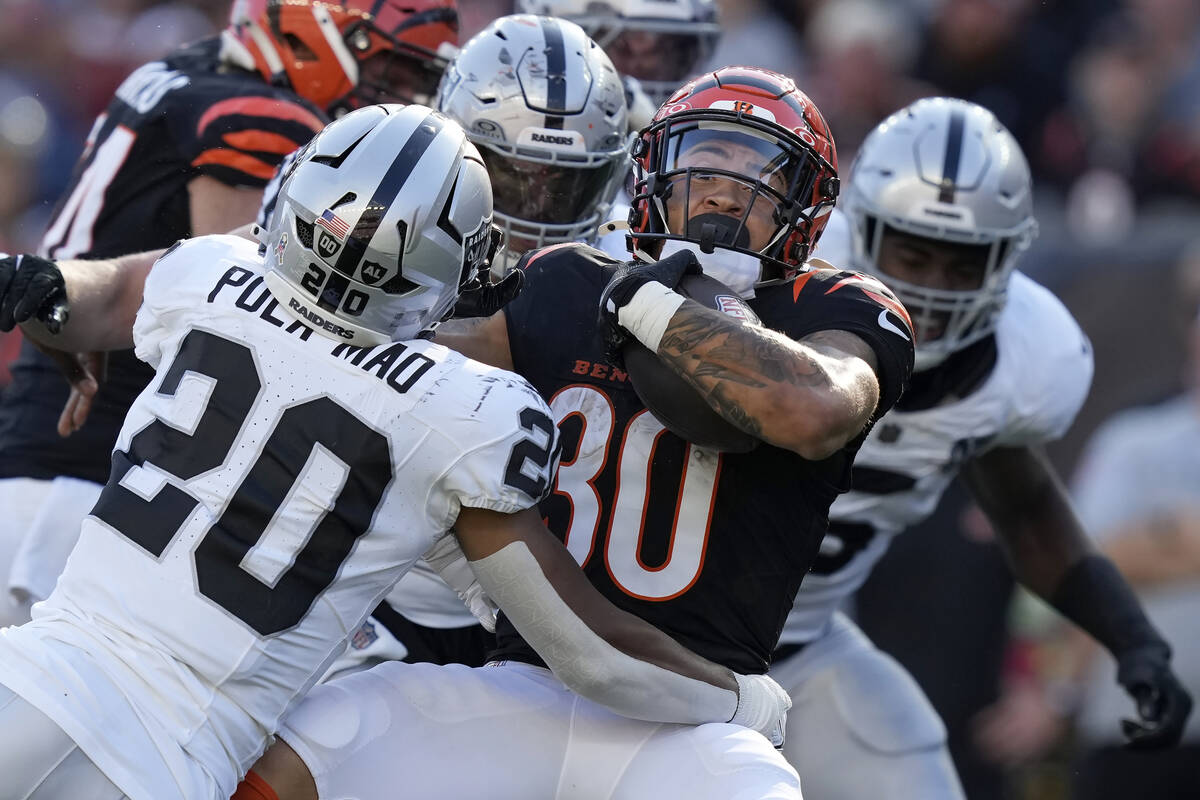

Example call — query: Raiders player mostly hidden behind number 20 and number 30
[319,14,630,674]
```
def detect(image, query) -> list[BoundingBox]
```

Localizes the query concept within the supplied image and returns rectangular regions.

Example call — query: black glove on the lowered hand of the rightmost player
[1117,644,1192,750]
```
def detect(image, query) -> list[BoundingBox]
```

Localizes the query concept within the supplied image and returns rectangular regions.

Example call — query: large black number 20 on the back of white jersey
[92,330,391,636]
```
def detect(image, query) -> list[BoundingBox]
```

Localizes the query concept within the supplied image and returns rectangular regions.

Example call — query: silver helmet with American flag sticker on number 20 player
[259,106,496,347]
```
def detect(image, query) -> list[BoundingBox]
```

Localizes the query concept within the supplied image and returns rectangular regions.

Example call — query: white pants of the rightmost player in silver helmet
[770,614,965,800]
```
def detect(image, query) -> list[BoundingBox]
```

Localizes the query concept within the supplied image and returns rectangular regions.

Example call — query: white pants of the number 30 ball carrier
[278,662,800,800]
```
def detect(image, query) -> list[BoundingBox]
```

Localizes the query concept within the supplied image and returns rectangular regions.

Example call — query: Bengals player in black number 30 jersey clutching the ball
[0,68,913,798]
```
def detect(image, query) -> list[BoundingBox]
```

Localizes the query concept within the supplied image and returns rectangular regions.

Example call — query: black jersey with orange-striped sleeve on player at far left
[0,37,324,483]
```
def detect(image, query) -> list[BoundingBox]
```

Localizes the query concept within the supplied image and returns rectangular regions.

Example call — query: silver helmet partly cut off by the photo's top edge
[517,0,721,106]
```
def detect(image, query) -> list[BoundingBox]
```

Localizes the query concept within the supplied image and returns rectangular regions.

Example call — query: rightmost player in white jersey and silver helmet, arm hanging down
[770,98,1190,800]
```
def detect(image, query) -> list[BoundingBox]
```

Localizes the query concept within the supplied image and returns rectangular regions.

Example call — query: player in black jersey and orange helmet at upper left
[0,0,457,624]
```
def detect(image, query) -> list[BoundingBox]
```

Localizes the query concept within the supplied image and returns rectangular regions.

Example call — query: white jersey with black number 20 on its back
[0,236,557,800]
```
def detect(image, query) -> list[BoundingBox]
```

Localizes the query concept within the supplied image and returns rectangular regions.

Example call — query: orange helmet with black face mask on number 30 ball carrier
[630,67,839,283]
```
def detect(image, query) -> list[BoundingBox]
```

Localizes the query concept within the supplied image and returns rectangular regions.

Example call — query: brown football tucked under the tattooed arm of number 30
[622,275,758,452]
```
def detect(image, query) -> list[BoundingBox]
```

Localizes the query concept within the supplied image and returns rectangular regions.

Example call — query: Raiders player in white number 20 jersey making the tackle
[0,106,787,800]
